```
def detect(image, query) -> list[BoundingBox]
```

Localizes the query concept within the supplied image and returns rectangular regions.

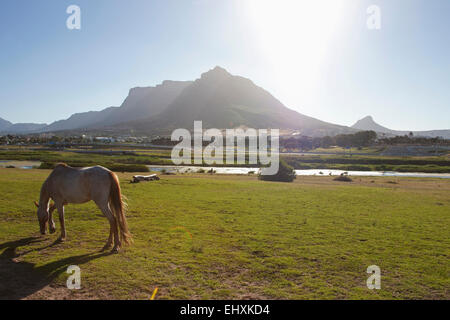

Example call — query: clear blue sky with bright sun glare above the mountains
[0,0,450,130]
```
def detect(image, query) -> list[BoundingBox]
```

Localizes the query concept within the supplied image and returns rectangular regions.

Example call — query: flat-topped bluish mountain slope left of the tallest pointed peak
[45,81,191,131]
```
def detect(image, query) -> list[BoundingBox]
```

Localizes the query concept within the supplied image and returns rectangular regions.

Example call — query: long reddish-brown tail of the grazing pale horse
[109,172,133,244]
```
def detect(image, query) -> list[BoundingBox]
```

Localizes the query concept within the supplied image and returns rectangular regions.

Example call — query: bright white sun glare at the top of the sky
[244,0,344,107]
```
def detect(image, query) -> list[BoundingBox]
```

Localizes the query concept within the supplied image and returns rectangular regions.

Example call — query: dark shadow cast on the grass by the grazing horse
[0,237,110,300]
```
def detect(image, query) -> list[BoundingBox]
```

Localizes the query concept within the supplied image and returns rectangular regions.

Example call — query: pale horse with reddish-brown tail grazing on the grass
[35,164,132,252]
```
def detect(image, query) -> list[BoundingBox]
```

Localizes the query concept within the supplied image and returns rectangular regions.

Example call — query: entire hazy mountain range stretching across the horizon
[0,66,450,138]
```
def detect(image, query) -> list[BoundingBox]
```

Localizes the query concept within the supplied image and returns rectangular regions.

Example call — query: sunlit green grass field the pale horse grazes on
[0,169,450,299]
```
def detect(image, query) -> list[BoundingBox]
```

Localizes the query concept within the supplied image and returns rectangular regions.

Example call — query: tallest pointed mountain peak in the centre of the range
[110,67,357,136]
